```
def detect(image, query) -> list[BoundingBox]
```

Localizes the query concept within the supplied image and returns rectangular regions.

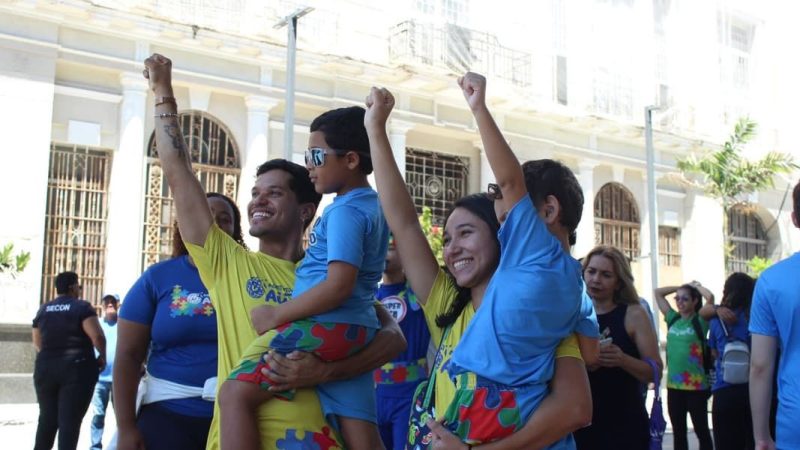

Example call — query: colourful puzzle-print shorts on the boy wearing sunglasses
[228,319,374,400]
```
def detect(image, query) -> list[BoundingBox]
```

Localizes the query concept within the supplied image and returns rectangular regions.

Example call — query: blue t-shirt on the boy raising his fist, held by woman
[449,195,598,388]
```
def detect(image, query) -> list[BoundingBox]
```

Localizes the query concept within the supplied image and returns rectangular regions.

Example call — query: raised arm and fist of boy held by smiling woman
[458,72,528,211]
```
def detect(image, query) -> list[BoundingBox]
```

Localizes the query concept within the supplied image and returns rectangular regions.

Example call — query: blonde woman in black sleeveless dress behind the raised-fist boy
[575,245,663,450]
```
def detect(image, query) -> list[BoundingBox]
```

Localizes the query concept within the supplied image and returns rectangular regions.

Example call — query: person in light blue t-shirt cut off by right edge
[750,178,800,450]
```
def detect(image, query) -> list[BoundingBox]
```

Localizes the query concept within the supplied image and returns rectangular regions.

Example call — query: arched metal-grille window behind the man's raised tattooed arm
[142,111,241,270]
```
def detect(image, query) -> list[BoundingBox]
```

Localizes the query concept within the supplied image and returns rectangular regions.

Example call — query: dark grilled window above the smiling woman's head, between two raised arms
[406,148,469,226]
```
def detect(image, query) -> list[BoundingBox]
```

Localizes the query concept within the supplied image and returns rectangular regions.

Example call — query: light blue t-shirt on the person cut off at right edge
[750,253,800,449]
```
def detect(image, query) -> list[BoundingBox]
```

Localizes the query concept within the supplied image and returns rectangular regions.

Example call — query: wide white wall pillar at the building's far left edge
[0,41,58,324]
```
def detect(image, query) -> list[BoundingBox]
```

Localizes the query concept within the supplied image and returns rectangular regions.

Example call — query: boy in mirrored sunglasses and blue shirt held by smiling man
[219,106,389,450]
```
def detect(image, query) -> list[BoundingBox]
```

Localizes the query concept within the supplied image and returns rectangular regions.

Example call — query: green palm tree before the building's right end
[678,117,800,267]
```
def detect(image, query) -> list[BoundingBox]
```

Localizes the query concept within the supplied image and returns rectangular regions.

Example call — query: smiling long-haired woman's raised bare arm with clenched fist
[364,87,439,305]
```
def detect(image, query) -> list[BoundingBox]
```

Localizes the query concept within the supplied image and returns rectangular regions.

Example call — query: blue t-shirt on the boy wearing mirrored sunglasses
[292,187,389,329]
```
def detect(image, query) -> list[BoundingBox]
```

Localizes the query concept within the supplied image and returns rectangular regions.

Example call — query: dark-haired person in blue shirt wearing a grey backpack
[700,272,755,450]
